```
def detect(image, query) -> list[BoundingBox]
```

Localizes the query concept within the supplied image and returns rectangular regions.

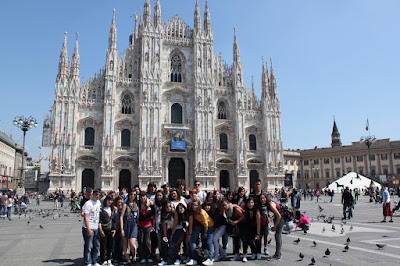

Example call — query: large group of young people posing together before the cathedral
[81,180,290,266]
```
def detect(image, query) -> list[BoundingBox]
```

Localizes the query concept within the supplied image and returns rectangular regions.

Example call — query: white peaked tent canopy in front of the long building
[324,172,381,190]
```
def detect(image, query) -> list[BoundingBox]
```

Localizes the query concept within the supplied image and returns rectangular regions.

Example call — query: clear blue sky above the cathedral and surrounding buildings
[0,0,400,159]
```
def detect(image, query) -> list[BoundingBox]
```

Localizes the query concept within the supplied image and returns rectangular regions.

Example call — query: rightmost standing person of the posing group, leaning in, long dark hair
[267,195,284,260]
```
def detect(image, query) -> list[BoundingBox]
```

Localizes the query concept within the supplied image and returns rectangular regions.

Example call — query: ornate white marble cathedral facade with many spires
[44,0,284,191]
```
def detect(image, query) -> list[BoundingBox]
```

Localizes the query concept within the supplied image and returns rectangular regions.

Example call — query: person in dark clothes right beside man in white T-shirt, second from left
[99,195,115,266]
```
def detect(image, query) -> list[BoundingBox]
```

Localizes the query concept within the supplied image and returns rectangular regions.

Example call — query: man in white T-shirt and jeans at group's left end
[82,190,101,266]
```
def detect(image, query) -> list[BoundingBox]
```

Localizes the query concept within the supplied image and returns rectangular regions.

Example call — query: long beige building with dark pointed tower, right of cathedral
[290,122,400,189]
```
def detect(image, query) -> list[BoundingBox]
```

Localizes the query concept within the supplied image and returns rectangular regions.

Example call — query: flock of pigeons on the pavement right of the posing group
[293,205,386,266]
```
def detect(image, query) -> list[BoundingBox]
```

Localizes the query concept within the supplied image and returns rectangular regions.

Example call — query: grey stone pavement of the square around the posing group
[0,194,400,265]
